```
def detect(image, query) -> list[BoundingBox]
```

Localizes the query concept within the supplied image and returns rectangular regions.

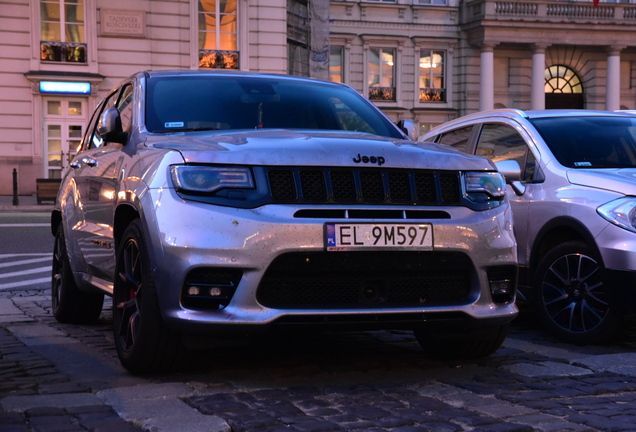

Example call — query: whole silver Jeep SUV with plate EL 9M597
[52,71,517,373]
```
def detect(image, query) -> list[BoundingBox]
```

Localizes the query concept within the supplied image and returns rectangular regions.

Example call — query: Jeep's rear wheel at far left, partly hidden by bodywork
[51,224,104,324]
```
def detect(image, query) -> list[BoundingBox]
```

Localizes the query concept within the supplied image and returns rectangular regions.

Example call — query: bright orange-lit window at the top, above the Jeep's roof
[198,0,239,69]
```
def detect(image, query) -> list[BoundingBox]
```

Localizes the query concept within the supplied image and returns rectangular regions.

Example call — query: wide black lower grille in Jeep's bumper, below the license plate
[257,252,473,309]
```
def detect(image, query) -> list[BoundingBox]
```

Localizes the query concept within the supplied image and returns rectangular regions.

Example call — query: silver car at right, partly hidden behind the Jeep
[420,109,636,343]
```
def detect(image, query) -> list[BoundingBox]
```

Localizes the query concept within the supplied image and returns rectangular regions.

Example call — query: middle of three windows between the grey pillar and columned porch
[367,48,396,101]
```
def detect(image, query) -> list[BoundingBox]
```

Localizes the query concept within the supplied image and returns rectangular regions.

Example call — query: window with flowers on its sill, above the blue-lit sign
[40,0,86,63]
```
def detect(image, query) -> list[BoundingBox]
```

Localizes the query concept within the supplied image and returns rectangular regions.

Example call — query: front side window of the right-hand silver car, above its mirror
[475,124,535,182]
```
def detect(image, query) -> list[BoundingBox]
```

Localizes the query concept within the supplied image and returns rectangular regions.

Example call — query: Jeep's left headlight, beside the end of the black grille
[170,165,254,193]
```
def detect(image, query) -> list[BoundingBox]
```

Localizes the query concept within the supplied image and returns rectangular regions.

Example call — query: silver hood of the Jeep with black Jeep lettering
[146,129,493,170]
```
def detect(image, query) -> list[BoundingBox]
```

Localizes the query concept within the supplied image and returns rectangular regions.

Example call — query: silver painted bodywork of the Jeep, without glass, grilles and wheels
[55,74,517,331]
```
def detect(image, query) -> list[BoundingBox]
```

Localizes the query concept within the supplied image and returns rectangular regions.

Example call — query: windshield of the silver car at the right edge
[530,116,636,168]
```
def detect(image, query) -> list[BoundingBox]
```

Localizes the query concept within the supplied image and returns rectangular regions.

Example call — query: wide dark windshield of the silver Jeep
[145,75,402,138]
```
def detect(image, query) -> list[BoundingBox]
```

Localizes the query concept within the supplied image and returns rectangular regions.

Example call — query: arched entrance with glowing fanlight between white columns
[545,65,585,109]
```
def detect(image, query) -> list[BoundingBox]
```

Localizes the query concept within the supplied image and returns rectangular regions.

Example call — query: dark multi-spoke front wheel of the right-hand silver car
[533,242,622,345]
